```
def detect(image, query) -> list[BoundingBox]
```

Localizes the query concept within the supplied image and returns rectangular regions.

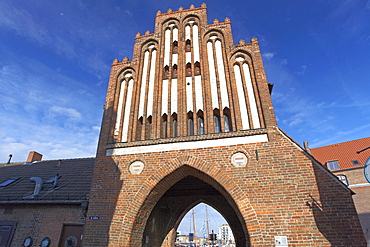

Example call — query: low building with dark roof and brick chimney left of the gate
[0,152,95,247]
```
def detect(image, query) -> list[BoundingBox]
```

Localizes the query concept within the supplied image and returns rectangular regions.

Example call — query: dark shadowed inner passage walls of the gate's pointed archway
[131,165,250,247]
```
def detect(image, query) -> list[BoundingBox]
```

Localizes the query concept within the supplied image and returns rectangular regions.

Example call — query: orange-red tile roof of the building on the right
[311,137,370,170]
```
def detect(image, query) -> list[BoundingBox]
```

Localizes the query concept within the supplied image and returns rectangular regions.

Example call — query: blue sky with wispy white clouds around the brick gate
[0,0,370,234]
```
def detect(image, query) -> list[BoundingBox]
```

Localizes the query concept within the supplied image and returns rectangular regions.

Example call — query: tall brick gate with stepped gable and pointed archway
[83,4,366,247]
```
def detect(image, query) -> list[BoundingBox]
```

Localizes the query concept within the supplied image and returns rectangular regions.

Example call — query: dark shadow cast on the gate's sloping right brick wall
[307,161,366,246]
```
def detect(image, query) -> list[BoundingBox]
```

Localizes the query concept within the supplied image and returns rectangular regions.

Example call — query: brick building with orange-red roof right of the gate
[311,137,370,246]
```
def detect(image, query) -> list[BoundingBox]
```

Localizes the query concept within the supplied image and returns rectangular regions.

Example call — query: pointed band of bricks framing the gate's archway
[121,155,262,246]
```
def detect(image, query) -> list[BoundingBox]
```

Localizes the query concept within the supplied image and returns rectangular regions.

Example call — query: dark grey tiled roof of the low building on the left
[0,158,95,203]
